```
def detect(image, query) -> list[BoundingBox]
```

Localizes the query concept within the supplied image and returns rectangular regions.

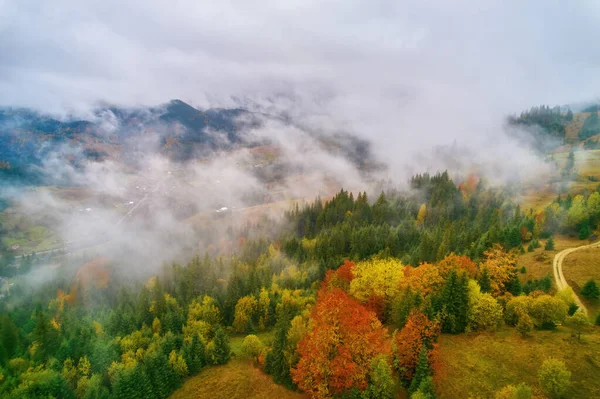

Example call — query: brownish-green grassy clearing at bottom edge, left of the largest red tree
[170,332,308,399]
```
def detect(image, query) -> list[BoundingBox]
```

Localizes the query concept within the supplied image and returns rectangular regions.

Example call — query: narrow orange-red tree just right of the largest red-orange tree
[394,311,440,381]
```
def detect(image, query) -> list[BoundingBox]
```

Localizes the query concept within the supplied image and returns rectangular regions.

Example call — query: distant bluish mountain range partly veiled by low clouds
[0,100,380,185]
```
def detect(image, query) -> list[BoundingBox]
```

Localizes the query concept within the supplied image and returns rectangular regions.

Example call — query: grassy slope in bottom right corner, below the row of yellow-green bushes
[438,327,600,399]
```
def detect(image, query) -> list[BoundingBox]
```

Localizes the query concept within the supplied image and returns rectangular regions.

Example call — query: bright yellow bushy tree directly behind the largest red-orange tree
[350,258,404,302]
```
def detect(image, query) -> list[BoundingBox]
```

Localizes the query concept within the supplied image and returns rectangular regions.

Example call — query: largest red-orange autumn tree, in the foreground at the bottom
[291,286,391,398]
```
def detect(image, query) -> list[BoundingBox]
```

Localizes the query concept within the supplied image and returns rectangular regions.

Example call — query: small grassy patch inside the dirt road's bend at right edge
[563,248,600,315]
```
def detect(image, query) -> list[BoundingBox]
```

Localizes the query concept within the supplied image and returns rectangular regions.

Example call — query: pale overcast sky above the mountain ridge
[0,0,600,166]
